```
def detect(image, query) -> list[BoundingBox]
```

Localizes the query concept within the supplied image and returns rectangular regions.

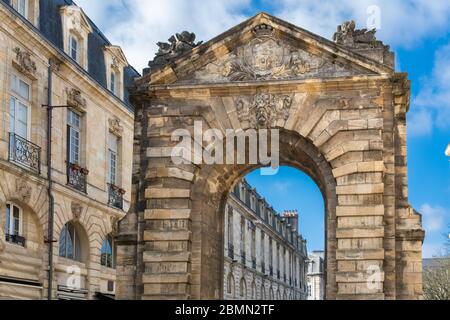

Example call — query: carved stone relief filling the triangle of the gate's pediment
[186,25,362,82]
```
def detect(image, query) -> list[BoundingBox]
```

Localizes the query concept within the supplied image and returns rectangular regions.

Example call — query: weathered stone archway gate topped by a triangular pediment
[117,13,424,299]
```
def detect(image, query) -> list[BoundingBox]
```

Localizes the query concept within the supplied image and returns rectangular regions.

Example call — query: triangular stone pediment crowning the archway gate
[144,13,393,84]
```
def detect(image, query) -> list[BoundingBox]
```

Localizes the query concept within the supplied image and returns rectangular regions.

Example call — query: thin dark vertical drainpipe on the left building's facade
[46,59,57,300]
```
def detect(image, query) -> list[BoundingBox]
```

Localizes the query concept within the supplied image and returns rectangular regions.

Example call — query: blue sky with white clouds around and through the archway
[76,0,450,257]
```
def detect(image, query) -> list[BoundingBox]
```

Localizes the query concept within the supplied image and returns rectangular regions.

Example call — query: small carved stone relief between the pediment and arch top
[235,93,293,128]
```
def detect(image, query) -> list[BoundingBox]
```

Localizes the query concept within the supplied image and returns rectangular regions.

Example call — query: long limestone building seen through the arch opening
[223,180,307,300]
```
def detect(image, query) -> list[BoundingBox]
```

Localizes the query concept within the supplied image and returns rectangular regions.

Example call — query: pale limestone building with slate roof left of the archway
[0,0,138,299]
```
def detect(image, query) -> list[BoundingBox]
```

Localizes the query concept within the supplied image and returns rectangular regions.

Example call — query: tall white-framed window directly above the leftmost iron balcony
[9,73,31,139]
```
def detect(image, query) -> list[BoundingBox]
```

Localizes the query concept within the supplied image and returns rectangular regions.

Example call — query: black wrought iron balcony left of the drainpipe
[9,133,41,174]
